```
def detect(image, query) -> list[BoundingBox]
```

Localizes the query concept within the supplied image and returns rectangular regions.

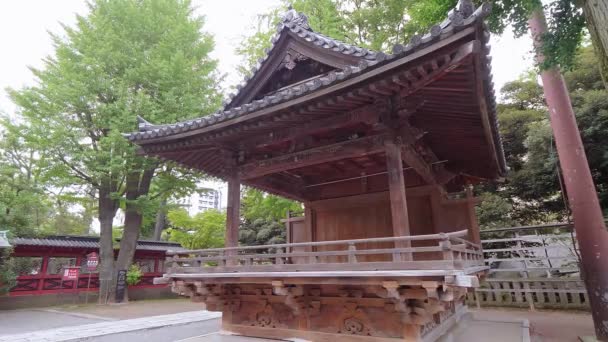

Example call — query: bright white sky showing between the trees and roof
[0,0,532,114]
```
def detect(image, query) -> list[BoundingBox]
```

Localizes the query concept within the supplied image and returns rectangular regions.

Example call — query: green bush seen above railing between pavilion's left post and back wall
[239,218,286,246]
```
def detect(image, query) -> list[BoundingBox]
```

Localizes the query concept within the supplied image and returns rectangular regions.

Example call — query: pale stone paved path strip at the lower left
[0,311,221,342]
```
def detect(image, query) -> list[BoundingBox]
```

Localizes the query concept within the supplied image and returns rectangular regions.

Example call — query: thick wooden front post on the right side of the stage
[384,139,412,261]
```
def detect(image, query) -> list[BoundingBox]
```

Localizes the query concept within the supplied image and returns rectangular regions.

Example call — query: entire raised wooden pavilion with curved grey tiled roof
[127,0,505,341]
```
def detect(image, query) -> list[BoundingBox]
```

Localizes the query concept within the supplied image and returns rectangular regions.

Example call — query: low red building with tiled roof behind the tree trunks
[0,235,185,309]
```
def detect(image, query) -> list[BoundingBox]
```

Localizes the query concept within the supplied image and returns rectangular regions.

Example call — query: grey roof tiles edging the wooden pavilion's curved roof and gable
[125,0,506,174]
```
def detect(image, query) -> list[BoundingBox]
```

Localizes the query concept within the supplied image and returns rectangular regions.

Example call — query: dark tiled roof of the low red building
[10,235,185,251]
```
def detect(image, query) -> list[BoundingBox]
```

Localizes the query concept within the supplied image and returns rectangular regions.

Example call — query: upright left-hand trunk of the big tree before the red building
[98,184,118,304]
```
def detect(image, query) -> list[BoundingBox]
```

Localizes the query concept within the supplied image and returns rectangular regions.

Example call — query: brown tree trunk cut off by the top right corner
[583,0,608,89]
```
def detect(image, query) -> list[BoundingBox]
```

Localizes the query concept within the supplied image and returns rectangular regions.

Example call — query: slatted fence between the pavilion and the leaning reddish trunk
[467,223,589,310]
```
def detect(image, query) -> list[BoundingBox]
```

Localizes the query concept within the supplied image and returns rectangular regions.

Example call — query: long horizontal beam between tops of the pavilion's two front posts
[239,134,387,180]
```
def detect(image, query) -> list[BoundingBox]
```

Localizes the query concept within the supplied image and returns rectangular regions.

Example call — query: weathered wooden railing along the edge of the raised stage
[167,231,484,275]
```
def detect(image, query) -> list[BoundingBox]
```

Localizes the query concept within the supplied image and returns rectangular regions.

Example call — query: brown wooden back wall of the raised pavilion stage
[307,186,480,262]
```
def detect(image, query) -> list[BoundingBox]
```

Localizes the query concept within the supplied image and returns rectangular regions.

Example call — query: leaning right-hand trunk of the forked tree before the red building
[115,167,155,301]
